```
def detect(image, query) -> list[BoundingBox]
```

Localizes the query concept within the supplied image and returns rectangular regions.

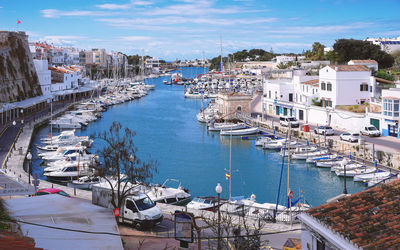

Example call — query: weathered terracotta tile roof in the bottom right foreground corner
[307,179,400,249]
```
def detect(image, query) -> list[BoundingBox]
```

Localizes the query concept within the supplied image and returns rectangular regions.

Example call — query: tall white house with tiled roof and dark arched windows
[319,65,375,107]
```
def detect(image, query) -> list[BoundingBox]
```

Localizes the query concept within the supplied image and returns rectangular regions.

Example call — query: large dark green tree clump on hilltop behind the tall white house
[330,39,394,68]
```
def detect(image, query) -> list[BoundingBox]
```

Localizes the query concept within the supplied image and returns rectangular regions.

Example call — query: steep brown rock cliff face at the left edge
[0,31,42,103]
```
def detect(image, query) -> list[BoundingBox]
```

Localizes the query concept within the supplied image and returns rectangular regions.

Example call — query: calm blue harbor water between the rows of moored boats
[32,68,365,206]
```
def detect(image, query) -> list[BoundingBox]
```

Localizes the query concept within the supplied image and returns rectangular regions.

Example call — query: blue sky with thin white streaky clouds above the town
[0,0,400,60]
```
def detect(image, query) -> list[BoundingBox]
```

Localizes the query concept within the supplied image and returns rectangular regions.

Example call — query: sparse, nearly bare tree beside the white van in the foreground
[91,122,157,208]
